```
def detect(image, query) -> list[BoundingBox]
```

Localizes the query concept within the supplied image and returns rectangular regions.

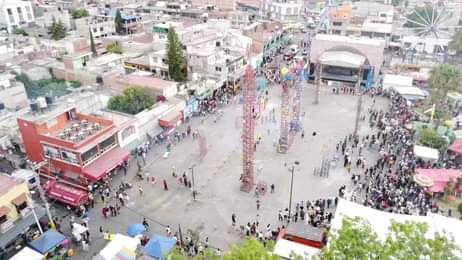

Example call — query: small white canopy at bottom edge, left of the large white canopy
[273,238,319,259]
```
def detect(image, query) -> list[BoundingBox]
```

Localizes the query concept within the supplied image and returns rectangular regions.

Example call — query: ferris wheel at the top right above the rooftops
[405,3,462,39]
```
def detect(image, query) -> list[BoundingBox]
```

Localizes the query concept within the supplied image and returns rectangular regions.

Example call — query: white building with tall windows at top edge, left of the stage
[263,0,304,22]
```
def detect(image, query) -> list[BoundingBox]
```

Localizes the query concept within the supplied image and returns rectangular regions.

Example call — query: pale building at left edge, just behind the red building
[0,74,29,110]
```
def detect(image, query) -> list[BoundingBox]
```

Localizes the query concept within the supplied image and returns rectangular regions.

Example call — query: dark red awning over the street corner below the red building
[44,180,88,207]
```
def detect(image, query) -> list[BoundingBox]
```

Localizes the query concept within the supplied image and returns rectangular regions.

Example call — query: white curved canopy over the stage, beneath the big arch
[319,51,366,68]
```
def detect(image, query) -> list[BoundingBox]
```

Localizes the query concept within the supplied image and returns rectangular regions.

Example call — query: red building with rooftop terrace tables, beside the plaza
[17,107,129,204]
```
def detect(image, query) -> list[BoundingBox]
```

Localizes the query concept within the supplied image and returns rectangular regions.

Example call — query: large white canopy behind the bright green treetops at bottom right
[331,199,462,247]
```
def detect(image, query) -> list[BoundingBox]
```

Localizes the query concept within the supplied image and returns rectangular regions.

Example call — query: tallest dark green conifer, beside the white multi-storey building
[166,27,187,82]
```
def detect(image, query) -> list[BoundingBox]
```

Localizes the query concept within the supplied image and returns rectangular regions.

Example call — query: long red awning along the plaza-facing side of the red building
[83,147,130,181]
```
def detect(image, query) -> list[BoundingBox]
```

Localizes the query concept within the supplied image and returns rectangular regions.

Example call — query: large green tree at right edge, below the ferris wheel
[428,64,462,107]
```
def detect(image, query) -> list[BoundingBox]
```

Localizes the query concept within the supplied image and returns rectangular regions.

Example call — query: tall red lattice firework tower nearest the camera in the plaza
[241,65,256,192]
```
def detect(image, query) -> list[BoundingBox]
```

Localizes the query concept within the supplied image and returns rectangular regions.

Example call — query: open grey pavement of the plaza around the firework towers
[57,82,386,259]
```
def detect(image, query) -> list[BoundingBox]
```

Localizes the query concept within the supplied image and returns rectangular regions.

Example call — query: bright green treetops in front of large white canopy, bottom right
[319,217,462,260]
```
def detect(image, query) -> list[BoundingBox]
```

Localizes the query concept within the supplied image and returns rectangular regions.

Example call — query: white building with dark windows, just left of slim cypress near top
[74,16,115,39]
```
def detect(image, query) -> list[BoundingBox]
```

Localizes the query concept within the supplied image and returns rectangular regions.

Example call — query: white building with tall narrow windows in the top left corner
[0,0,35,32]
